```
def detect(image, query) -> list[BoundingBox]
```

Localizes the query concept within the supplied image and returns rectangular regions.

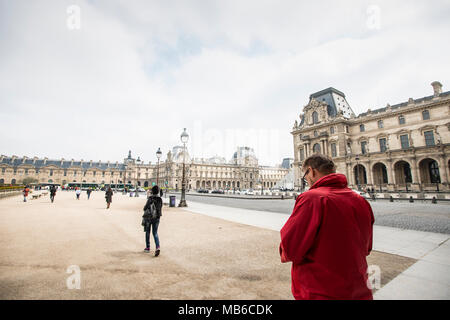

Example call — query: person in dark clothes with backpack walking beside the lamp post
[142,186,163,257]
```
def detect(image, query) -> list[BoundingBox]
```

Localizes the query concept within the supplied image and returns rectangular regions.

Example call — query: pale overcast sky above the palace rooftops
[0,0,450,165]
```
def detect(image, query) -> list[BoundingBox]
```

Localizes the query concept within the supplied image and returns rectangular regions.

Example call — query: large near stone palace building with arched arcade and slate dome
[291,81,450,192]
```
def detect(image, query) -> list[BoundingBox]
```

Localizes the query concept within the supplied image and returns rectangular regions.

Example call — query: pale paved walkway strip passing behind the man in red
[185,201,450,299]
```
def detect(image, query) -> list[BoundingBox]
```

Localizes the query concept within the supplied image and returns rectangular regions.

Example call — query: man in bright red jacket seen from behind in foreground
[279,154,375,300]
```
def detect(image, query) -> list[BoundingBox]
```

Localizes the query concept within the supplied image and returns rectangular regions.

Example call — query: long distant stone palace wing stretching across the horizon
[0,146,291,190]
